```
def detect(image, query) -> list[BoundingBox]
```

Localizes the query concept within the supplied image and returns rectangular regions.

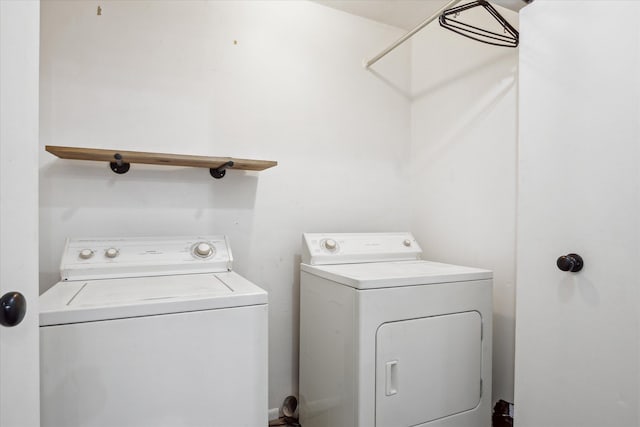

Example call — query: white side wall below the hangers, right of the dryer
[410,8,518,401]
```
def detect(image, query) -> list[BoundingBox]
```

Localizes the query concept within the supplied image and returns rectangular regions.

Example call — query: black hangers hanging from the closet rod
[439,0,520,47]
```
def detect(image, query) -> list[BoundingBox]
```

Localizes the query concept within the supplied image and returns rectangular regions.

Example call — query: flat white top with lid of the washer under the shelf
[40,272,267,326]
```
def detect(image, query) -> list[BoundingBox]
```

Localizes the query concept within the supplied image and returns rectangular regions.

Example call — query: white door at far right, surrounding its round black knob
[515,0,640,427]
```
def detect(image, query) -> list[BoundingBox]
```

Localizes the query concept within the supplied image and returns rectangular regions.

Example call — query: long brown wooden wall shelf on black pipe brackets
[45,145,278,178]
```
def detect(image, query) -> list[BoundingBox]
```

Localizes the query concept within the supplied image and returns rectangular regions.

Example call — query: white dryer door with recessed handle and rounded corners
[376,311,482,427]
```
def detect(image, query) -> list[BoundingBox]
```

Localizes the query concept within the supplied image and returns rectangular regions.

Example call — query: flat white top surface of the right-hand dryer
[300,260,493,289]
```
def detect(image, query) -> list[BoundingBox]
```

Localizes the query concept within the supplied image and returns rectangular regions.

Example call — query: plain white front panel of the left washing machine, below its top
[40,304,268,427]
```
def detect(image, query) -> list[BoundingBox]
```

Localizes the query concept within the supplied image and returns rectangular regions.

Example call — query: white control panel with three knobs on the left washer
[60,236,233,280]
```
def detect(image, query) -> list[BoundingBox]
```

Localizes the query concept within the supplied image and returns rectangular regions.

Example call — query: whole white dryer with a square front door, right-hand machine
[299,233,492,427]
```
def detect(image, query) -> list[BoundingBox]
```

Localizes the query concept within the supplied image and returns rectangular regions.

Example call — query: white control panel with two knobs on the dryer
[302,233,422,265]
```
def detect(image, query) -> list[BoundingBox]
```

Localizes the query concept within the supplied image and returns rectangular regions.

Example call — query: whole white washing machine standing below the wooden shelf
[40,236,268,427]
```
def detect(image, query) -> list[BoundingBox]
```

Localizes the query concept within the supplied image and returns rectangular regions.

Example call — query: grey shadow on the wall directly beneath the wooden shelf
[40,159,258,210]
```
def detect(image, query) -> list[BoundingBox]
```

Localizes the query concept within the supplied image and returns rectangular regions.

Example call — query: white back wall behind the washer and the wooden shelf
[40,0,410,414]
